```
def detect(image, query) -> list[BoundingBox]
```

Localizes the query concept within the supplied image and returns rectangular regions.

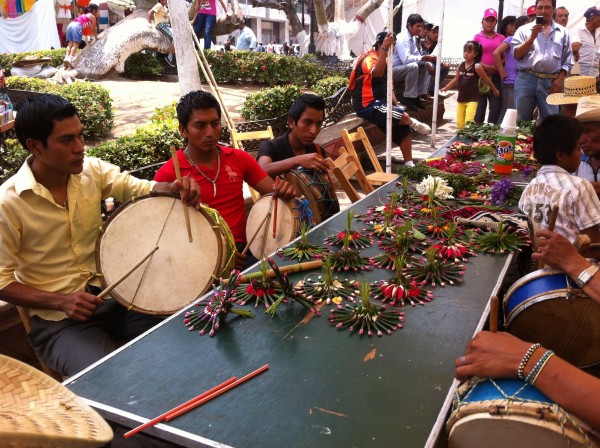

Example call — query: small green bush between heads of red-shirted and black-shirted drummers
[241,84,301,121]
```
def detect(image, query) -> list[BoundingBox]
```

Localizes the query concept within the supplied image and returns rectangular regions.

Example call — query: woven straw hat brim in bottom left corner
[0,355,113,448]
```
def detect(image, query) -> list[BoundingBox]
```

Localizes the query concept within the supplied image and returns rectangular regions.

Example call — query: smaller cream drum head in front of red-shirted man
[246,195,299,259]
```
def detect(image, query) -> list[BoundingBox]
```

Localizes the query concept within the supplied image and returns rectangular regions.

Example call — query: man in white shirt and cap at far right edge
[573,6,600,78]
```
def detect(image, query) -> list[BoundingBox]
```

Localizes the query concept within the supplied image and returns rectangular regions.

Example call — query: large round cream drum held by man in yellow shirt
[96,195,223,315]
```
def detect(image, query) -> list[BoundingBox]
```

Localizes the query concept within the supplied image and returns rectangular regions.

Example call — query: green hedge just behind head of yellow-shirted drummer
[6,76,114,139]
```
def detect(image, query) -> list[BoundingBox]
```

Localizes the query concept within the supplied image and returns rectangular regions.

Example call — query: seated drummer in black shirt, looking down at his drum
[257,93,327,177]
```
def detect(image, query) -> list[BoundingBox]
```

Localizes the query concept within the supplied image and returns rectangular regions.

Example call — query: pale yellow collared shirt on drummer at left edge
[0,157,154,320]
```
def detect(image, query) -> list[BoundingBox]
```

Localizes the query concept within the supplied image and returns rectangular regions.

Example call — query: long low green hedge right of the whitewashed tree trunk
[205,50,330,87]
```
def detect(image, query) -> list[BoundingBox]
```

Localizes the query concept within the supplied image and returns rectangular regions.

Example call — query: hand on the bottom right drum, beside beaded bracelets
[454,331,531,380]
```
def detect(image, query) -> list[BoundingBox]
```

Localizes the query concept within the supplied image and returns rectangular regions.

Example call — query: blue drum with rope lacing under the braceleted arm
[446,379,598,448]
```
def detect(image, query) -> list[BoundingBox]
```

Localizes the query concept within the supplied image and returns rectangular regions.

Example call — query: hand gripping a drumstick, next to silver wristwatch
[531,229,590,278]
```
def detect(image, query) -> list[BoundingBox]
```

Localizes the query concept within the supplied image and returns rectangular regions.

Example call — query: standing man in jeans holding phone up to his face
[511,0,573,120]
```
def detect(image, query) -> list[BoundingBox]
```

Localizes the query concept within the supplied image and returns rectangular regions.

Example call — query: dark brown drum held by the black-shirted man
[284,167,340,224]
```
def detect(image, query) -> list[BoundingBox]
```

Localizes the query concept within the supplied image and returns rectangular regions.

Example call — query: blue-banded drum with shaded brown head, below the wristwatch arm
[503,268,600,367]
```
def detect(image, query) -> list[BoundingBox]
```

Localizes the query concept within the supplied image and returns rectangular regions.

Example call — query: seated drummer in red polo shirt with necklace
[154,90,296,269]
